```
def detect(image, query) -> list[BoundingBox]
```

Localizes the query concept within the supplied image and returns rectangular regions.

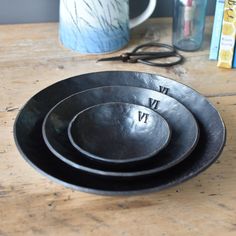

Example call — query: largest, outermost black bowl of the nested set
[14,71,226,195]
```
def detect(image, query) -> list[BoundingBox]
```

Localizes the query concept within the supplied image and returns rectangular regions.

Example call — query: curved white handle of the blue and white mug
[129,0,157,29]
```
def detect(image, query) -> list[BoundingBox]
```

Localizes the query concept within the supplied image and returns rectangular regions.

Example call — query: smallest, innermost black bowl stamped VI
[68,102,171,163]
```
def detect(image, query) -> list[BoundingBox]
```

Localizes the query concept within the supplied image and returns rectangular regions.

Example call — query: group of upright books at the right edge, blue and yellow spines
[210,0,236,68]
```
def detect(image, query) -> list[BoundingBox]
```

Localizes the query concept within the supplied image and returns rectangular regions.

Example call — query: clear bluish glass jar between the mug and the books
[172,0,207,51]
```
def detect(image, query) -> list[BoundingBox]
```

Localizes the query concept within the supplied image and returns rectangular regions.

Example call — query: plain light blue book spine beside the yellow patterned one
[209,0,225,60]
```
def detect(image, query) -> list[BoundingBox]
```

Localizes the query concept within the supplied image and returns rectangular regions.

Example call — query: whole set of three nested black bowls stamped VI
[14,71,226,195]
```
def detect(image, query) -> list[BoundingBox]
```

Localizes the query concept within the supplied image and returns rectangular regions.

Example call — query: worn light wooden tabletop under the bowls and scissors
[0,19,236,236]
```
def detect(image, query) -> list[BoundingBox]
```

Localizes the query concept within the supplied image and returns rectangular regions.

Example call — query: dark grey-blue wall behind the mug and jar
[0,0,215,24]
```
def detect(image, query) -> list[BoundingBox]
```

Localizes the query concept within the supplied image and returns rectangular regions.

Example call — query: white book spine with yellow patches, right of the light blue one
[217,0,236,68]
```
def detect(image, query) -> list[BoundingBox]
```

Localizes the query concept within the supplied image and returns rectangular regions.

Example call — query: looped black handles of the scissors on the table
[128,43,184,67]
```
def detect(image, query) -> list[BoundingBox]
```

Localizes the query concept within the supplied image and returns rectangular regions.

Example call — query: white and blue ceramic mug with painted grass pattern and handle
[59,0,157,53]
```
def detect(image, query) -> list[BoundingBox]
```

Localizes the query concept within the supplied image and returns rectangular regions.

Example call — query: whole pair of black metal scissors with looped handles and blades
[97,43,184,67]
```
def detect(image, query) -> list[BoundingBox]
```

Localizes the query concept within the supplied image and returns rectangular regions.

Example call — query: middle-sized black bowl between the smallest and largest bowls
[42,86,198,177]
